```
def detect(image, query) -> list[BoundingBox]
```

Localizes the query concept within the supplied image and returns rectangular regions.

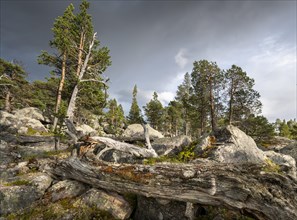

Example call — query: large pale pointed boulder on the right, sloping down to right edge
[195,125,296,177]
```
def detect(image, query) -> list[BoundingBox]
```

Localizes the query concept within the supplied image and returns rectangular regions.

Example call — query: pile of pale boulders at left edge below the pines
[0,109,48,134]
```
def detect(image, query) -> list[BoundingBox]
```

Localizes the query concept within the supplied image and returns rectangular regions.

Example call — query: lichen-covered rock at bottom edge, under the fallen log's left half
[75,188,133,219]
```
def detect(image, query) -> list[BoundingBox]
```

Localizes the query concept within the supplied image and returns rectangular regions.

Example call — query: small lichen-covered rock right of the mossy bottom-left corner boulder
[47,180,87,202]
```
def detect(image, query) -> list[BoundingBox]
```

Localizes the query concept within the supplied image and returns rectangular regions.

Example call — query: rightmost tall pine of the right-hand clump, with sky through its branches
[225,65,262,124]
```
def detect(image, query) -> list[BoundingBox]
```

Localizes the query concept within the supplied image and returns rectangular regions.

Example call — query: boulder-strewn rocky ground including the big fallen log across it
[0,108,297,220]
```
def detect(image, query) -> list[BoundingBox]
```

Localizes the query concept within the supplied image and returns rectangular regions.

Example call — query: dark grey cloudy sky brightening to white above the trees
[0,0,297,121]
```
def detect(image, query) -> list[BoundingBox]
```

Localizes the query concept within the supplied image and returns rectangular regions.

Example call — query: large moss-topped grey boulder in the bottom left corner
[0,173,52,216]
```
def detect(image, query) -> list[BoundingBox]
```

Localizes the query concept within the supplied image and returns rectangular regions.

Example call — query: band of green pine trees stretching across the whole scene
[0,0,297,140]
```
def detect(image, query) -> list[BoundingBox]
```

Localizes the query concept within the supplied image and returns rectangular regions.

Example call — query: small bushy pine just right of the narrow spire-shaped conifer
[144,92,164,130]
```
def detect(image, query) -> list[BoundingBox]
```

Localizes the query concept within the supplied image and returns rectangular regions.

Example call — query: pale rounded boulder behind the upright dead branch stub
[123,124,164,140]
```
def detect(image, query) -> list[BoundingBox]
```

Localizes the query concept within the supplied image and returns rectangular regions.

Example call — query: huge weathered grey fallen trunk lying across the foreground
[47,157,297,220]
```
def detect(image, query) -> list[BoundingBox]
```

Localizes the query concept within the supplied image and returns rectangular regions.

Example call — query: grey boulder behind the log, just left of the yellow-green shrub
[152,135,192,156]
